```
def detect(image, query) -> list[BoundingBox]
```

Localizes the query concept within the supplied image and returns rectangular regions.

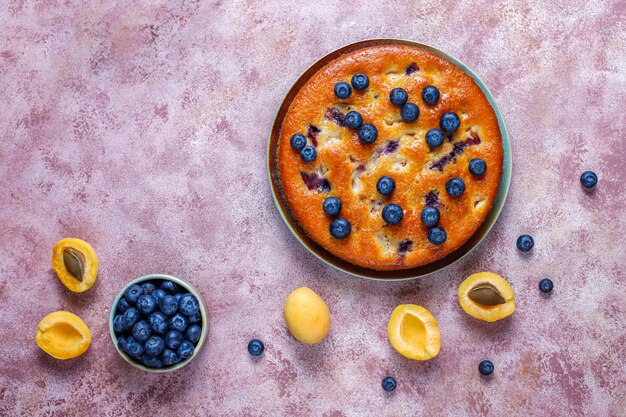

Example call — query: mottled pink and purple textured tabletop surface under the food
[0,0,626,416]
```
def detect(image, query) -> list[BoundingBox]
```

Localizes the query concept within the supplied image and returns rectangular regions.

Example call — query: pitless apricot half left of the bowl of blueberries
[35,311,91,359]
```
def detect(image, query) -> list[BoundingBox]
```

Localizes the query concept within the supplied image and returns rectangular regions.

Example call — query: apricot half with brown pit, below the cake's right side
[458,272,515,322]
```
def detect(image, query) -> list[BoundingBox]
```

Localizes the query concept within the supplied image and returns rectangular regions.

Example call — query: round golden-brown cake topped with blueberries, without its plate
[277,45,503,270]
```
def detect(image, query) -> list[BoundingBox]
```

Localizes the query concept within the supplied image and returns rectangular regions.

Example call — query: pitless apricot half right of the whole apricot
[387,304,441,361]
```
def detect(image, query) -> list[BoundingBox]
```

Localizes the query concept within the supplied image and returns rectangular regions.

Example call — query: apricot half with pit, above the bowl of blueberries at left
[52,238,98,292]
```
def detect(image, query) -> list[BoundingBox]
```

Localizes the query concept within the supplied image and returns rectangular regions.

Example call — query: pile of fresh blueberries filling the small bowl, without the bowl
[113,280,202,368]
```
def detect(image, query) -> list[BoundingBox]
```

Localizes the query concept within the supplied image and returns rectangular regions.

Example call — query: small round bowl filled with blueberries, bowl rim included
[109,274,209,372]
